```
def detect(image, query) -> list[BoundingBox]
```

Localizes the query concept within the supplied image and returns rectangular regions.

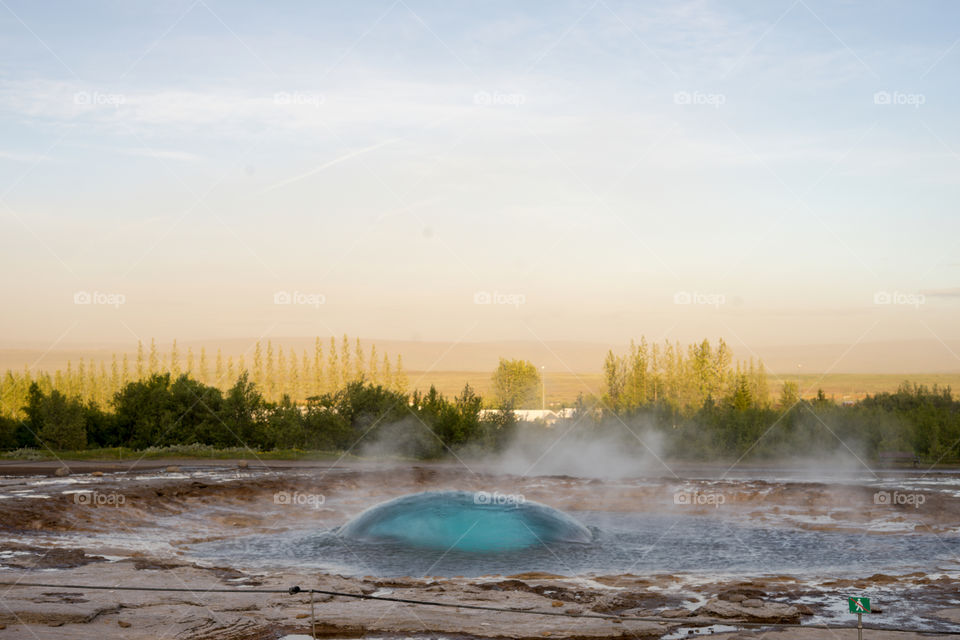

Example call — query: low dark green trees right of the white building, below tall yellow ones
[578,383,960,463]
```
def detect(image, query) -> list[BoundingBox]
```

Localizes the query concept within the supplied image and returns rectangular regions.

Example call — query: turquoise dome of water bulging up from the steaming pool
[339,491,592,552]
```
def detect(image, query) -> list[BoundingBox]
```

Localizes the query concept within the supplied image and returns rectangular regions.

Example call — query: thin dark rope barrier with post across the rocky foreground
[0,582,960,636]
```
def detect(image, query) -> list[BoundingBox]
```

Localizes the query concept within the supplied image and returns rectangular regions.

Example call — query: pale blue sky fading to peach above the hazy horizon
[0,0,960,366]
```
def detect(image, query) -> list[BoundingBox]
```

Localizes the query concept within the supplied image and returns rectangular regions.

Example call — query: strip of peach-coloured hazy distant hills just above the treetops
[0,336,960,376]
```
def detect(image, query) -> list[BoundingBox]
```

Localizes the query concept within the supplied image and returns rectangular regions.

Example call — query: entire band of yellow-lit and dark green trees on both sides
[0,337,960,461]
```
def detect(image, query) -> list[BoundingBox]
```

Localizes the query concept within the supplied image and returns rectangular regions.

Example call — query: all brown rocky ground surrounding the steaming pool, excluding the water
[0,461,960,640]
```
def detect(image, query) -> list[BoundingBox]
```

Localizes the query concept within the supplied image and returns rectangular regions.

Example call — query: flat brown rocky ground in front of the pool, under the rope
[0,545,957,640]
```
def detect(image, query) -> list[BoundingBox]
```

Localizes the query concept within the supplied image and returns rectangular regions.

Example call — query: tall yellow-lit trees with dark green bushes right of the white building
[596,339,960,461]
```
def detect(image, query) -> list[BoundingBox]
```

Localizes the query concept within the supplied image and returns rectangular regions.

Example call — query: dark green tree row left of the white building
[0,371,516,458]
